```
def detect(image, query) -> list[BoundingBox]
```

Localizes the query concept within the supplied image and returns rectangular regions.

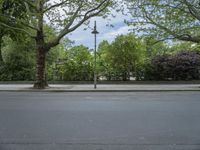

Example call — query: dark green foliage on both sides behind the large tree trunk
[0,26,71,81]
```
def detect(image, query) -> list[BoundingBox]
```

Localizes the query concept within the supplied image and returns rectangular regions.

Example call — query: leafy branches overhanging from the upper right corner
[127,0,200,43]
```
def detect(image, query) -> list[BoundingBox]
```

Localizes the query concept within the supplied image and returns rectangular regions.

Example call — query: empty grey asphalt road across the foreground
[0,92,200,150]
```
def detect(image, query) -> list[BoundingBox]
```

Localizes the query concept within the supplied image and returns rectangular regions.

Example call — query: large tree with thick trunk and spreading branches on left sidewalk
[1,0,111,88]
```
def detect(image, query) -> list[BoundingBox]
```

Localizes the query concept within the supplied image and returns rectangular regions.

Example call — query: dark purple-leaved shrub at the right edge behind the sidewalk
[143,51,200,80]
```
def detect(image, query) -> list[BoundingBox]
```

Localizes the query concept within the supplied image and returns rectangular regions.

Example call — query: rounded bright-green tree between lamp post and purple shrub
[109,34,144,81]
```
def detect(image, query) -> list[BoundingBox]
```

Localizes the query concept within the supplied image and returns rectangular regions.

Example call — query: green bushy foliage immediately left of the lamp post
[59,45,93,81]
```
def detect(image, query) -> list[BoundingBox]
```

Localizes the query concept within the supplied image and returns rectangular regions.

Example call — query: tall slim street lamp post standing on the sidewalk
[92,21,99,89]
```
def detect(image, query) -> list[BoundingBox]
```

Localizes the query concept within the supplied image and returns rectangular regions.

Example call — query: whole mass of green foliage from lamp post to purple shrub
[99,34,145,81]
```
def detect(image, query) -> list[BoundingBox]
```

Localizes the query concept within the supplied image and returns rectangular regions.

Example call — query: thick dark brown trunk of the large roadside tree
[34,33,48,89]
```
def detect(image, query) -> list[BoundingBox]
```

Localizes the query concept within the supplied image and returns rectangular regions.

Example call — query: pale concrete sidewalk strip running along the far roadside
[0,84,200,92]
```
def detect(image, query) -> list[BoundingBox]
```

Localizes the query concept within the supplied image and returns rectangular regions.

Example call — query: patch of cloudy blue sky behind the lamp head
[68,13,131,49]
